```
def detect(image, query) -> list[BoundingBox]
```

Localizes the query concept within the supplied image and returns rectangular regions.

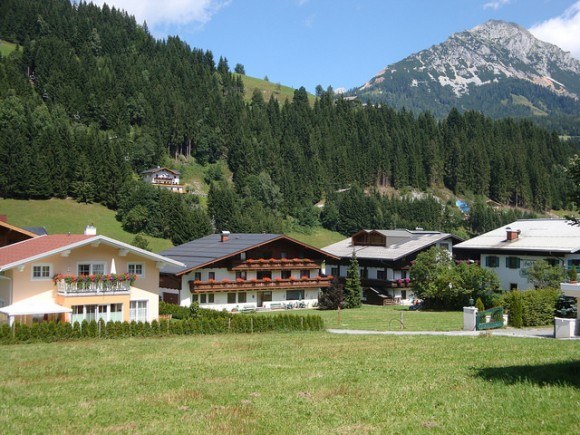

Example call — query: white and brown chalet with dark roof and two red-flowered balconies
[160,231,338,311]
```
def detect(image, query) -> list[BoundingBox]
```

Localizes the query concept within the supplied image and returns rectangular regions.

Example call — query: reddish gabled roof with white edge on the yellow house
[0,234,183,272]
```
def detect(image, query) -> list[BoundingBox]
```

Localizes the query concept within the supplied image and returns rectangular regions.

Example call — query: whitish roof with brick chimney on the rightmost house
[454,219,580,253]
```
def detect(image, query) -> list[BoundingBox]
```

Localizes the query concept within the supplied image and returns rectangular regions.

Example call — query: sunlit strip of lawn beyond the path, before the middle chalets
[264,305,463,331]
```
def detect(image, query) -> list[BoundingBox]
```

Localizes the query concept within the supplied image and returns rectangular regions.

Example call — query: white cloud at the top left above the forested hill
[91,0,230,28]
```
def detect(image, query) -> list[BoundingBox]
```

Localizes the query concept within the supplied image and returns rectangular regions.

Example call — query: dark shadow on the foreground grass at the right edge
[475,360,580,388]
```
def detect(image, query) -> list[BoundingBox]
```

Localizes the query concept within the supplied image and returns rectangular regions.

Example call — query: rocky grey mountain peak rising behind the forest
[346,20,580,135]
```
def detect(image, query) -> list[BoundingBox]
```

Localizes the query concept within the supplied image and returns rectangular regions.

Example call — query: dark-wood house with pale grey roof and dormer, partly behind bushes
[322,229,461,305]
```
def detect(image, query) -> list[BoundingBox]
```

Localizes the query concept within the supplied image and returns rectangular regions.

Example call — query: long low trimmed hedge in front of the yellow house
[0,316,324,344]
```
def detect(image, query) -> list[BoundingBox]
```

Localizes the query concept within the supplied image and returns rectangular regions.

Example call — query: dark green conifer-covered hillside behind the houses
[0,0,571,243]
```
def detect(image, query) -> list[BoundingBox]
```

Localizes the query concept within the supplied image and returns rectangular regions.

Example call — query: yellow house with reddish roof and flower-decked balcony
[0,226,183,324]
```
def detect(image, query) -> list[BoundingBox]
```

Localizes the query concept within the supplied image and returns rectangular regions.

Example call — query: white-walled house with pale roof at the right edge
[455,219,580,290]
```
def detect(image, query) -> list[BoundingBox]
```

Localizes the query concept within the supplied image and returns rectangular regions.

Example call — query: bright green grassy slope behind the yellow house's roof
[0,199,172,252]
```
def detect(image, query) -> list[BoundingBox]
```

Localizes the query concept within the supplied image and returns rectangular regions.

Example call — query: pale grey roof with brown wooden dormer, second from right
[322,229,461,261]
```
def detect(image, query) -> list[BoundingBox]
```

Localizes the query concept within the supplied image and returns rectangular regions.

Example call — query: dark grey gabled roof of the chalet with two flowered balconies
[161,233,340,275]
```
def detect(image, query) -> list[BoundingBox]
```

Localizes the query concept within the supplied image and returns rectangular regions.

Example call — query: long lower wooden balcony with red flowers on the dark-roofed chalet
[189,276,331,293]
